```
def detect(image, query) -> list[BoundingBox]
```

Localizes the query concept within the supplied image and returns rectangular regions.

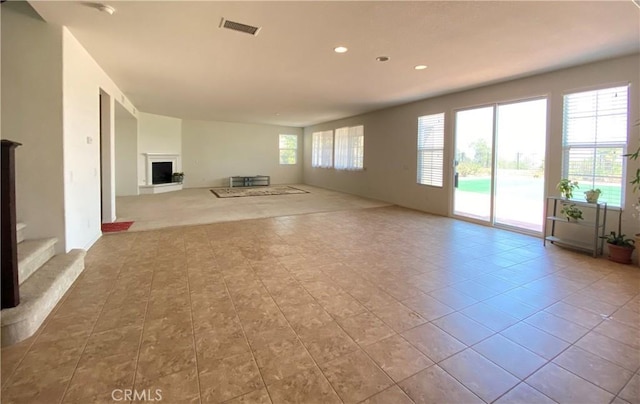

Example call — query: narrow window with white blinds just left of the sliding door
[418,113,444,187]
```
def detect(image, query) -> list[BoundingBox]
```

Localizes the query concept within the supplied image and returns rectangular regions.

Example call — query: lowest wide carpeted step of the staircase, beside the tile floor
[0,250,86,346]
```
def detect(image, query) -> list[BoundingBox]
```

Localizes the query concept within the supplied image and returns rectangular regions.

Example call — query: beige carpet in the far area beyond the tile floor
[116,184,389,232]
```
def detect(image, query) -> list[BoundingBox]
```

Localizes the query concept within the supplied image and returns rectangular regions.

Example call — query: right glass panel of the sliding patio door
[494,99,547,232]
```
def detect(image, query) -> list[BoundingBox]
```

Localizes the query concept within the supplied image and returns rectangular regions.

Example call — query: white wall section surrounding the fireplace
[138,112,183,185]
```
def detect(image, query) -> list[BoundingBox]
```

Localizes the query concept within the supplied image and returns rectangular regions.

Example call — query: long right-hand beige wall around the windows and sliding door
[304,54,640,234]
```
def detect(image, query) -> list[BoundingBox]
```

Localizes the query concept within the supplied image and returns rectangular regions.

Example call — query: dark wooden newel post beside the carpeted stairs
[0,139,21,309]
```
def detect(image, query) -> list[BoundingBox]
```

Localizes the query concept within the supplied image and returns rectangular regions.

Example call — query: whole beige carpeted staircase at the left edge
[0,223,85,346]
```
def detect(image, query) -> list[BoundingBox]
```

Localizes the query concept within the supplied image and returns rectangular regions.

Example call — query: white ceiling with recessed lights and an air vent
[30,0,640,126]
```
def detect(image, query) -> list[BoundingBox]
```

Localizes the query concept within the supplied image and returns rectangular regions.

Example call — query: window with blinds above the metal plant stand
[562,86,628,206]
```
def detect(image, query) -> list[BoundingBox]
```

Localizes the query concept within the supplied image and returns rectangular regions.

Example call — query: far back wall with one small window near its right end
[182,120,303,188]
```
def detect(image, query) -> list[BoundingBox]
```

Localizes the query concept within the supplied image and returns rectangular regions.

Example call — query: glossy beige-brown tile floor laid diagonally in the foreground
[2,207,640,404]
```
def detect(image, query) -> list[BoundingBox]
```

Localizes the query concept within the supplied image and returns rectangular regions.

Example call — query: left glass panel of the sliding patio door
[453,106,494,222]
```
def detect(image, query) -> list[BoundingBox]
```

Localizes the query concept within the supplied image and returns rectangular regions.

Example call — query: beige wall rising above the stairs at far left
[0,1,65,251]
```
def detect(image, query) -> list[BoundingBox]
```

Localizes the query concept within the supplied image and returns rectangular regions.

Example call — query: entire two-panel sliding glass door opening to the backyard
[453,99,547,232]
